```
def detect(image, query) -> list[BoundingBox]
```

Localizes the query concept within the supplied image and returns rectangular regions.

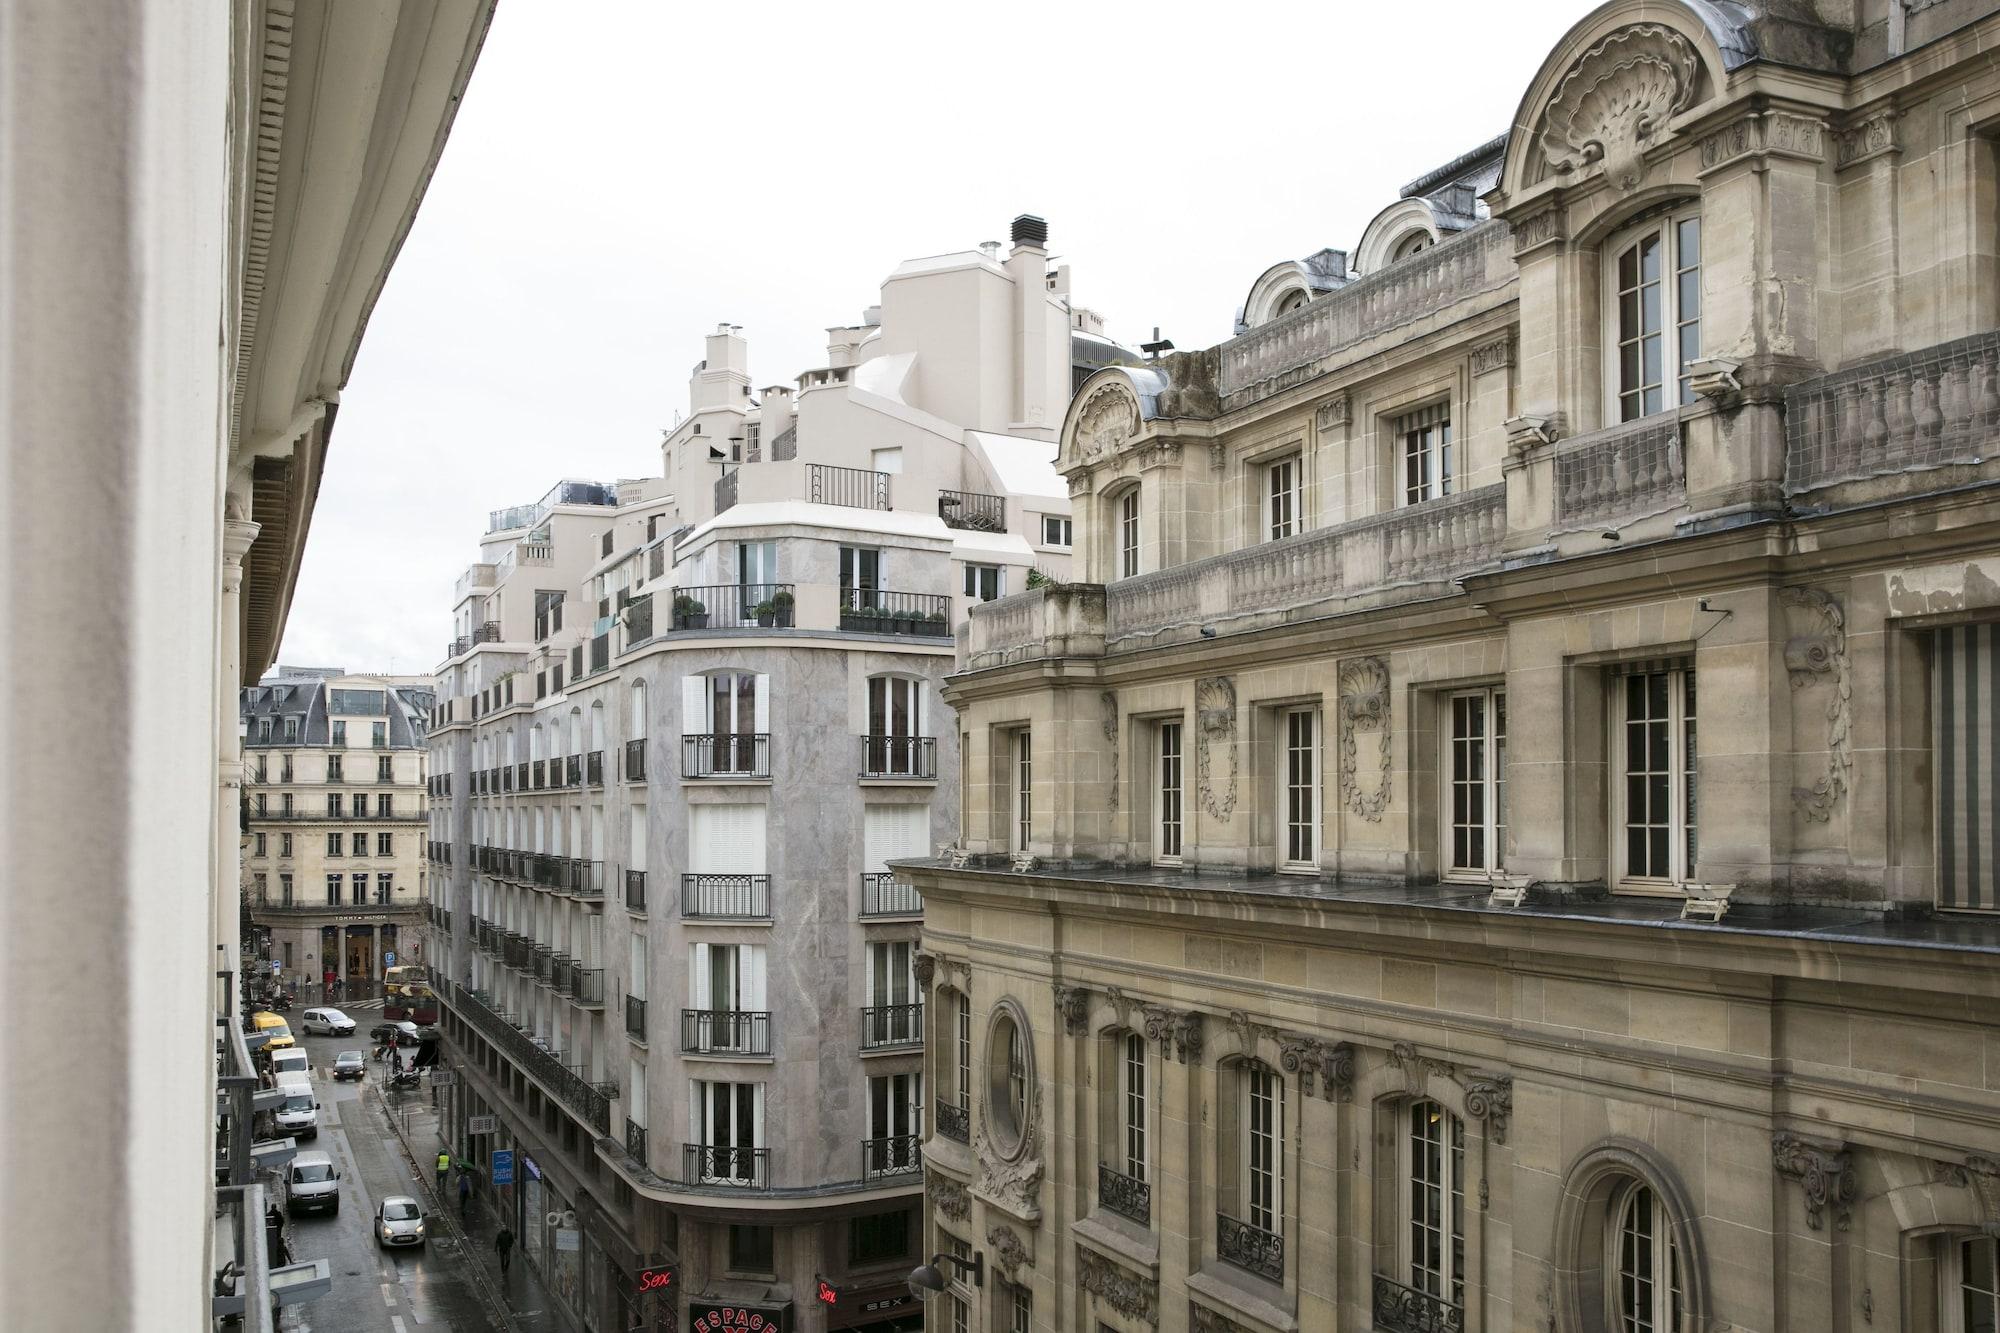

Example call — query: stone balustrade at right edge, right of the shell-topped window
[1784,332,2000,494]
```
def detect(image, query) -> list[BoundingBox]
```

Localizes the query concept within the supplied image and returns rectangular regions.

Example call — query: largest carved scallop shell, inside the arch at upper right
[1542,24,1702,190]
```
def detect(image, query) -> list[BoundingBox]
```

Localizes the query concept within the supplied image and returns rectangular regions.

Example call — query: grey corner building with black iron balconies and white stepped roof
[418,218,1118,1333]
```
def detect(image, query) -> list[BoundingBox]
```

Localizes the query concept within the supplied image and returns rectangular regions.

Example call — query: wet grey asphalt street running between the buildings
[282,1020,560,1333]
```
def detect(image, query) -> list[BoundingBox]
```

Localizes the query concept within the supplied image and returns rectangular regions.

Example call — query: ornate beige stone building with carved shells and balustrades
[912,0,2000,1333]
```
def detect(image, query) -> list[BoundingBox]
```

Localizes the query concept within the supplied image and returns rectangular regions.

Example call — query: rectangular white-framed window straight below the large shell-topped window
[1612,667,1696,889]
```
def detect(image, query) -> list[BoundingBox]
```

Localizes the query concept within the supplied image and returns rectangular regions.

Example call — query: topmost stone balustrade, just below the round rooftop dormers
[1220,222,1514,406]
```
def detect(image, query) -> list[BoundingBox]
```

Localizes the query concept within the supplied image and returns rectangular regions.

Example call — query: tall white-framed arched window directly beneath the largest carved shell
[1604,212,1702,420]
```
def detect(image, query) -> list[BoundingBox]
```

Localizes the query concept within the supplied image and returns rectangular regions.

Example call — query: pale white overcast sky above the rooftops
[280,0,1590,673]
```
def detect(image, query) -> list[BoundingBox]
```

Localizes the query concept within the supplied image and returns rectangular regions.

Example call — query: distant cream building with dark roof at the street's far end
[242,667,434,995]
